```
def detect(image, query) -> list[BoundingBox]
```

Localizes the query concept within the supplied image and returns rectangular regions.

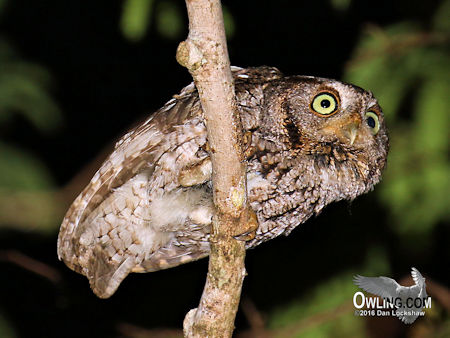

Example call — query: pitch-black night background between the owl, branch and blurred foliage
[0,0,450,337]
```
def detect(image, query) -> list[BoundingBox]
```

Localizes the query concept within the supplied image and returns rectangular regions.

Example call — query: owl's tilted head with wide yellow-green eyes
[264,76,389,194]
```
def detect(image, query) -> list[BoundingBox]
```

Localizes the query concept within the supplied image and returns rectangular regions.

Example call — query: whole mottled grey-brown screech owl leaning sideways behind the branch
[58,67,388,298]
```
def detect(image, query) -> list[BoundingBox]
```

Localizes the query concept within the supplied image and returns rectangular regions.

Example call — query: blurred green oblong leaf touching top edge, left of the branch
[120,0,153,42]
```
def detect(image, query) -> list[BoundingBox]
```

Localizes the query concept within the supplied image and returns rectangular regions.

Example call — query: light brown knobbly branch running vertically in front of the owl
[177,0,248,337]
